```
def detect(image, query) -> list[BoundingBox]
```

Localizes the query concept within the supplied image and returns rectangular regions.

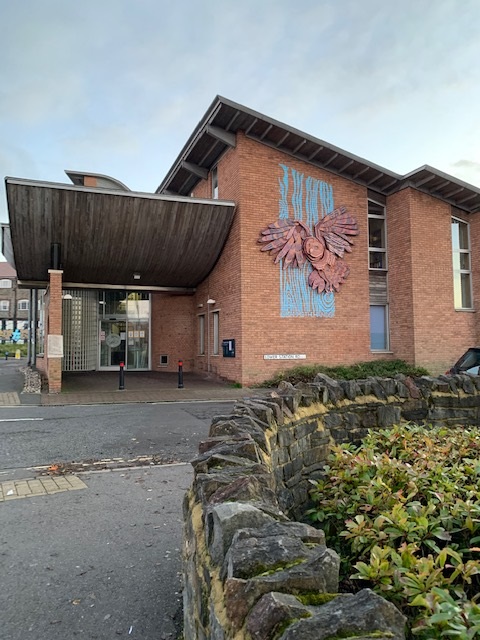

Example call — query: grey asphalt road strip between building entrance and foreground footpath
[0,402,232,478]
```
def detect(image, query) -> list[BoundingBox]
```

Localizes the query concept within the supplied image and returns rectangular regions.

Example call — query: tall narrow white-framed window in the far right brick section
[452,218,473,309]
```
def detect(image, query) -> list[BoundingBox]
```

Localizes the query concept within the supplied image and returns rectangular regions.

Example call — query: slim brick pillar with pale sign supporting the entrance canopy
[46,269,63,393]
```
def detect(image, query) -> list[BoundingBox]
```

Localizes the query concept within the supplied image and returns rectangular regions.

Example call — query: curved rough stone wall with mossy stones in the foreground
[184,375,480,640]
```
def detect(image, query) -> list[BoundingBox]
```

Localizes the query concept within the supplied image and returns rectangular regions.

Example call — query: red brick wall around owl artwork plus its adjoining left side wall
[188,134,371,384]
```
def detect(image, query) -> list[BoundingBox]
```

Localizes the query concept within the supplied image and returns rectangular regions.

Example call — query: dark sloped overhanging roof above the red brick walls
[157,96,480,213]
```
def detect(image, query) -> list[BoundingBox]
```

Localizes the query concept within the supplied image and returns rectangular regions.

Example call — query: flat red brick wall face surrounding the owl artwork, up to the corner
[239,136,371,382]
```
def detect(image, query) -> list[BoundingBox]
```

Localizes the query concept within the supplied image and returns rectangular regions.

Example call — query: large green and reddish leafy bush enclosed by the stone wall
[309,425,480,640]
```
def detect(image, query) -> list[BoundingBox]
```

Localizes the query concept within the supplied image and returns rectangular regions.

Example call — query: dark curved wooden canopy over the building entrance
[3,178,235,289]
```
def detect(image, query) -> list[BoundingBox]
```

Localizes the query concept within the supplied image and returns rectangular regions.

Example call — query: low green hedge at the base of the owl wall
[260,360,429,387]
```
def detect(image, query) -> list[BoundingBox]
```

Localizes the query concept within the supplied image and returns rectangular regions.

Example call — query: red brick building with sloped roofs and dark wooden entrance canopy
[3,97,480,391]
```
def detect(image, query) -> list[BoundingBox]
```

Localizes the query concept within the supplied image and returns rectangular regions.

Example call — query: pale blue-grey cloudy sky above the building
[0,0,480,221]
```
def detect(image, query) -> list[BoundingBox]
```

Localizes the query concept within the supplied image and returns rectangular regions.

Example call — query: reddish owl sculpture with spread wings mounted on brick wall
[258,207,358,293]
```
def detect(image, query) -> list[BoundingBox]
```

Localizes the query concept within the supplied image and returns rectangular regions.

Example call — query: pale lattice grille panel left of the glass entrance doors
[62,289,98,371]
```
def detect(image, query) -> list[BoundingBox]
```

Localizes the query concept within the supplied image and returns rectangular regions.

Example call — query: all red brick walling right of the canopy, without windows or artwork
[163,134,480,384]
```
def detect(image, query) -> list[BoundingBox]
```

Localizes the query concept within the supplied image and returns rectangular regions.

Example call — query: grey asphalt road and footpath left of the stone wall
[0,403,235,640]
